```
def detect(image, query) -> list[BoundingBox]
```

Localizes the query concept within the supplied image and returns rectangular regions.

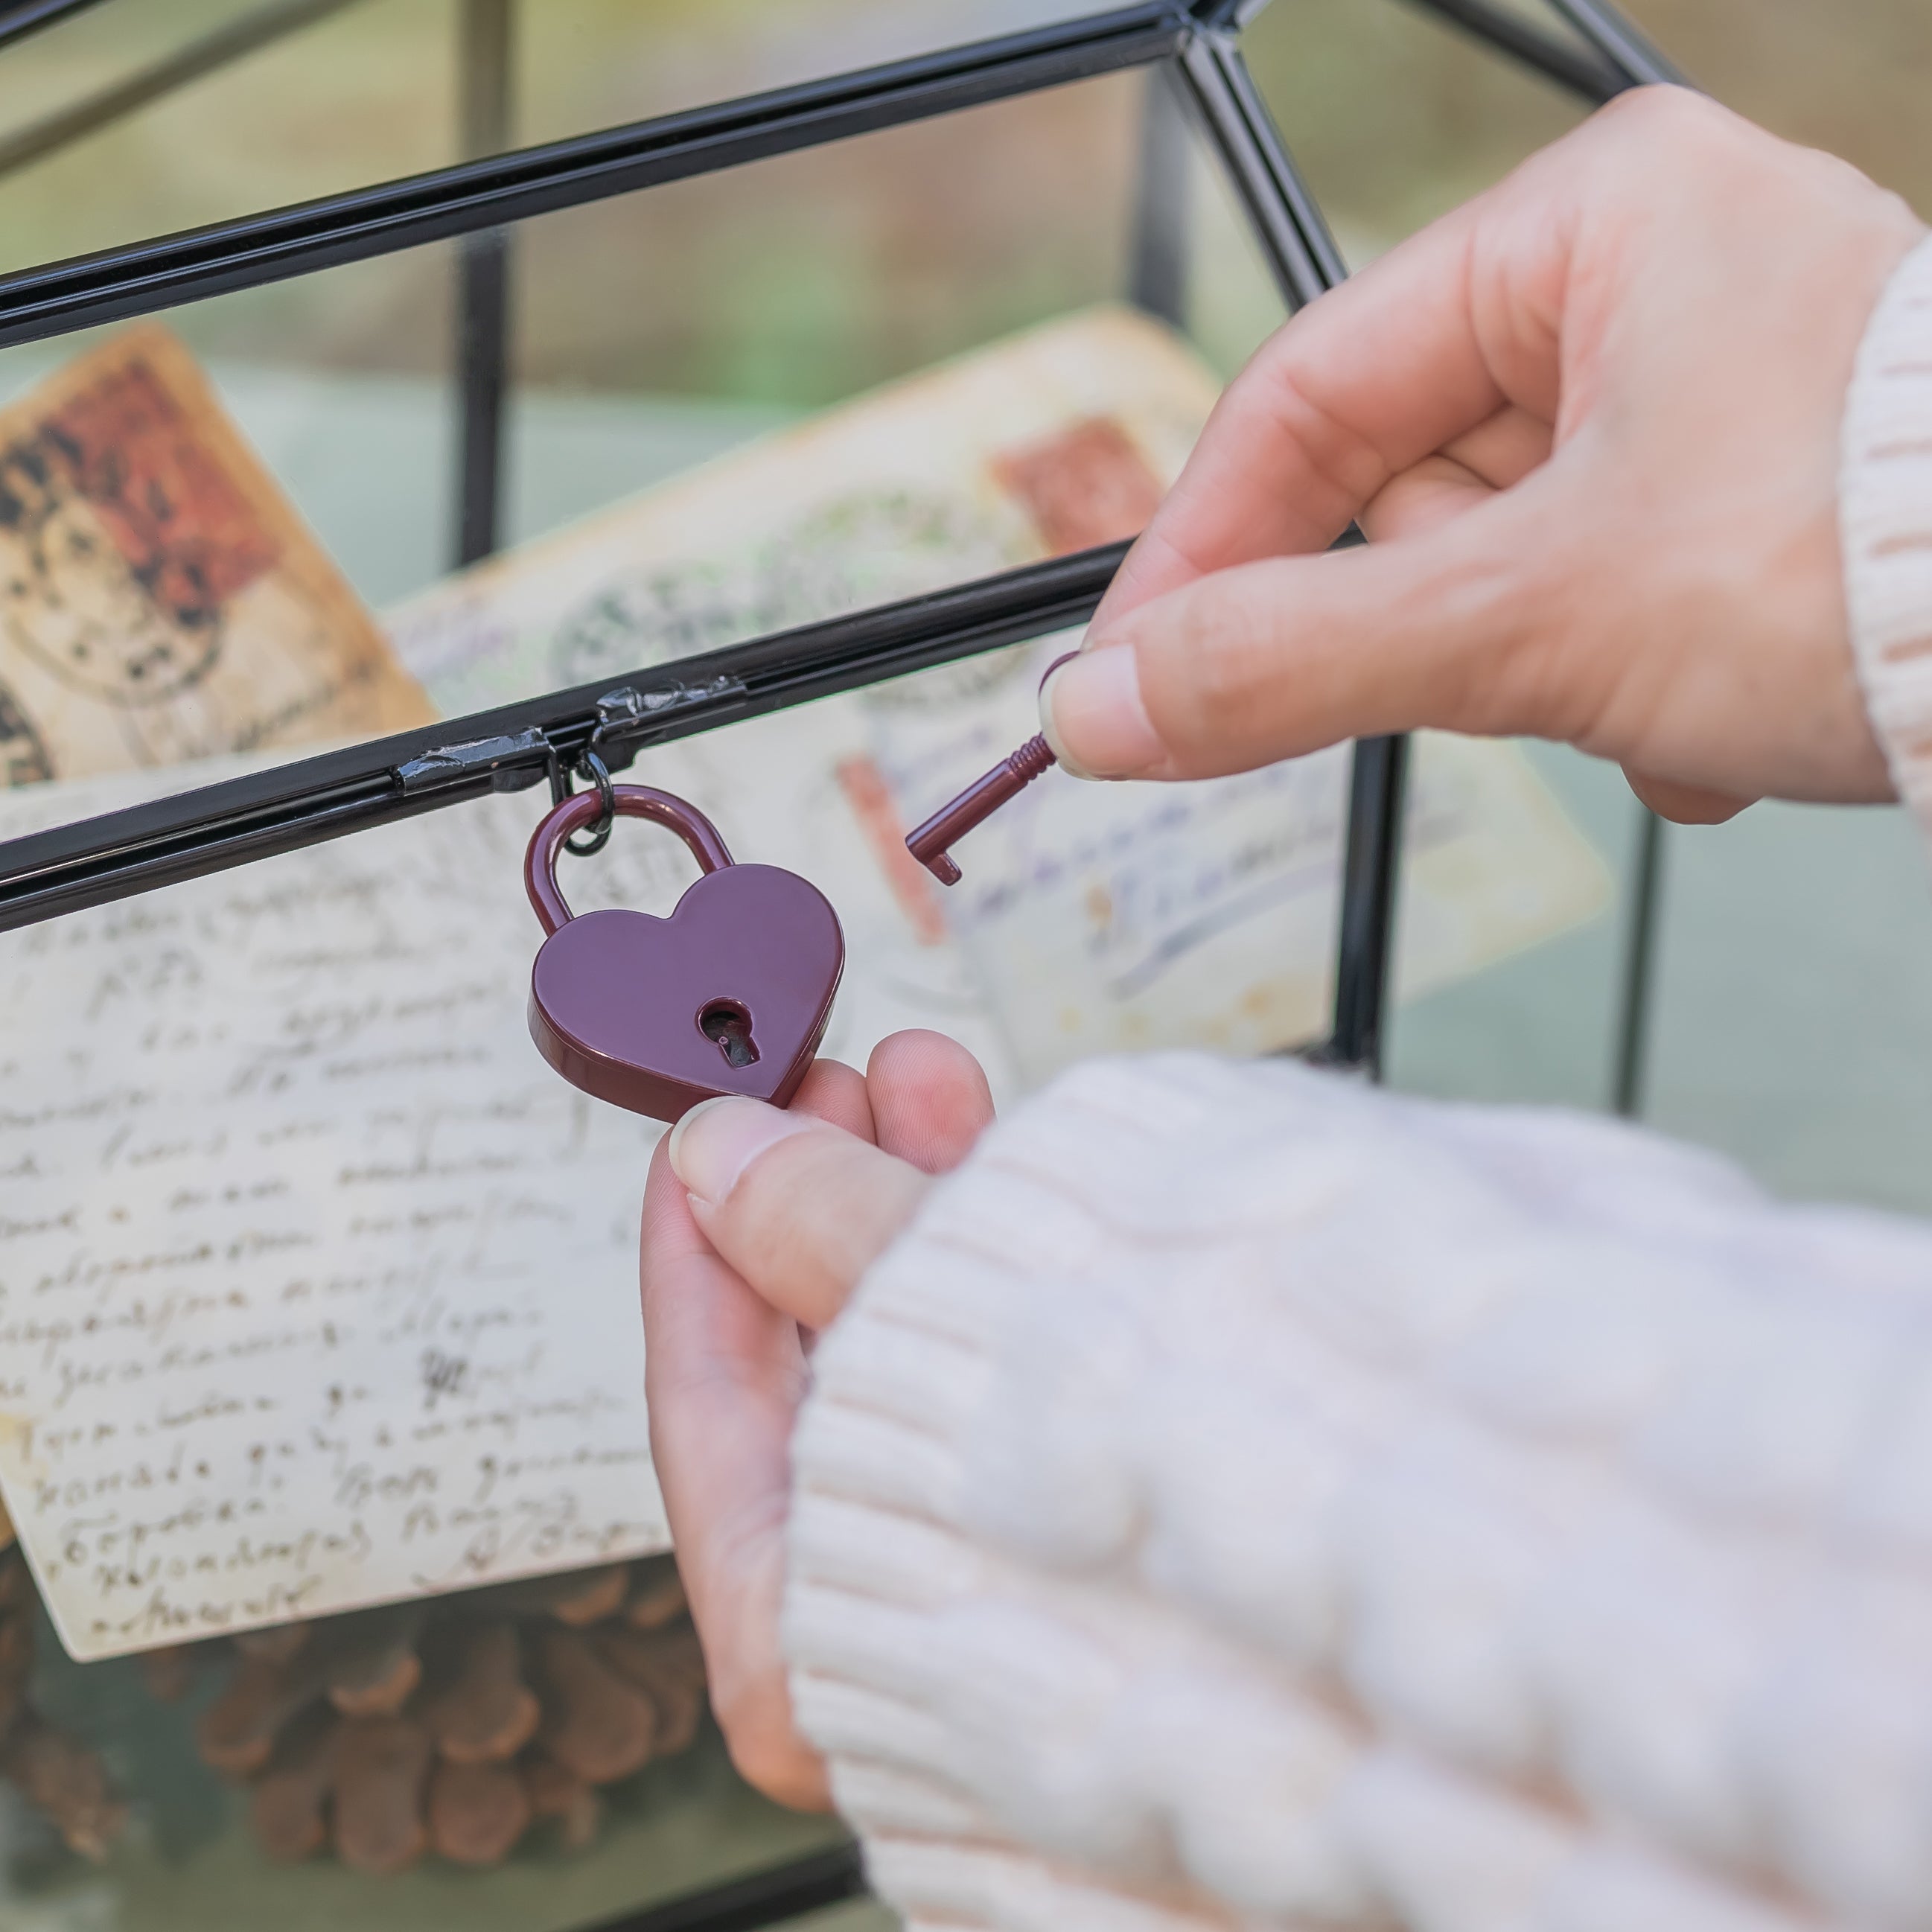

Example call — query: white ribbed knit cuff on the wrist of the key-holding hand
[1839,241,1932,844]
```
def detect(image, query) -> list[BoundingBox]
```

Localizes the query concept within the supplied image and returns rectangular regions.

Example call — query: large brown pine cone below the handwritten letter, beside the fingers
[182,1559,705,1874]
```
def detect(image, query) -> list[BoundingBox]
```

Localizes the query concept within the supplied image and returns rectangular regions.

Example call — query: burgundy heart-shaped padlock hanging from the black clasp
[523,785,844,1120]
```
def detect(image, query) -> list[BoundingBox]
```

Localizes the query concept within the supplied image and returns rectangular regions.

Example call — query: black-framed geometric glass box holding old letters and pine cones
[0,0,1671,1932]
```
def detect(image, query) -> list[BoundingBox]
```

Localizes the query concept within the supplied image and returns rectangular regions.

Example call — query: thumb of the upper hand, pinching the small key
[1039,498,1548,779]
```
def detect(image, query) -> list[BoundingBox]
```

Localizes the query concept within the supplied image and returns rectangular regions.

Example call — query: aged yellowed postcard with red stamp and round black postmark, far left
[0,327,435,785]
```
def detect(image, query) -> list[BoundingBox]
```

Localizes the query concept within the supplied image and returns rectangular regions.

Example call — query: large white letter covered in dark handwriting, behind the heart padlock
[0,713,1010,1658]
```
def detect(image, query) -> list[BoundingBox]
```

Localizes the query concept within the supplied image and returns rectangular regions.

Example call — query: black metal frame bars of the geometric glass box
[0,0,1679,1901]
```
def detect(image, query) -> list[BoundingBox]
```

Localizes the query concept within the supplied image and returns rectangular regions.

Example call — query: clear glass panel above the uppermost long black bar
[0,0,1128,270]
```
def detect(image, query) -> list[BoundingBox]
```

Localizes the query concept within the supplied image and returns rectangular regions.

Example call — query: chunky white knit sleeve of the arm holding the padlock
[786,1056,1932,1932]
